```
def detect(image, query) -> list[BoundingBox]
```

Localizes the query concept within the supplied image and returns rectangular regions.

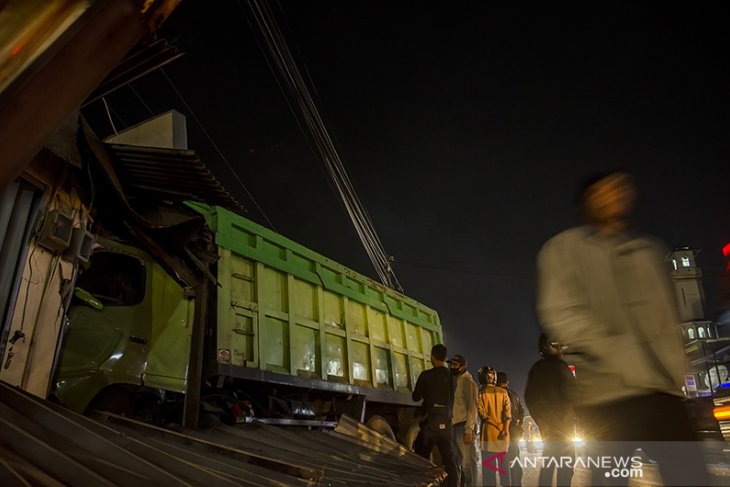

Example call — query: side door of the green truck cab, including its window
[56,251,151,411]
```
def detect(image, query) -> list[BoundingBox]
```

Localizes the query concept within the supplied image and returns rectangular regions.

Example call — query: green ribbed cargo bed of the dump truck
[190,204,442,392]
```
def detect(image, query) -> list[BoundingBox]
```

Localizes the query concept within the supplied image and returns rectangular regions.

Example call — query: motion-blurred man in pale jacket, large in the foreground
[537,170,709,485]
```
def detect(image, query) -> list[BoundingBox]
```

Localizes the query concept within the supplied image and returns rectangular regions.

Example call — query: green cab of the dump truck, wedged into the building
[55,239,194,412]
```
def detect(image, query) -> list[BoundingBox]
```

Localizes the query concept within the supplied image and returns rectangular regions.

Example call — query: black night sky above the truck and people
[88,0,730,402]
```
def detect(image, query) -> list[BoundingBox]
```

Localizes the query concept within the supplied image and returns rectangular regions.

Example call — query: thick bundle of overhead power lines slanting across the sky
[245,0,403,291]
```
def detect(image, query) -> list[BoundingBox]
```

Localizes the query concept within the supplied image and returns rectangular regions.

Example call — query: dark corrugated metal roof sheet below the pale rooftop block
[106,144,245,211]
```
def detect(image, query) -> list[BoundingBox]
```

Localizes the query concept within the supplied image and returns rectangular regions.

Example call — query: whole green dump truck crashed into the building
[55,203,443,438]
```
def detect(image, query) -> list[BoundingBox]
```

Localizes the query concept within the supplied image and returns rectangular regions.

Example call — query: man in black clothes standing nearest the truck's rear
[413,344,459,487]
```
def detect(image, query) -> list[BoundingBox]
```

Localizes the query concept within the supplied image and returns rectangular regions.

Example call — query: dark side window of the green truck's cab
[76,252,145,306]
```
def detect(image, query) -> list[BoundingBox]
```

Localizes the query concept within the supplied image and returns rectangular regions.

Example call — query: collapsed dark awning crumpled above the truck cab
[80,118,233,289]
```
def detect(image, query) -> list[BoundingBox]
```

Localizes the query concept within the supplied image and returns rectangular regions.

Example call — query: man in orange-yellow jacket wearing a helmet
[477,367,512,486]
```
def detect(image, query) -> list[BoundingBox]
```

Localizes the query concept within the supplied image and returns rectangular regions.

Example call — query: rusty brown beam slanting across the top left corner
[0,0,179,194]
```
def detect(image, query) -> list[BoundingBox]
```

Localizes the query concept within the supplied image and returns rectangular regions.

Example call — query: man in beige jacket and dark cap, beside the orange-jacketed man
[449,355,480,487]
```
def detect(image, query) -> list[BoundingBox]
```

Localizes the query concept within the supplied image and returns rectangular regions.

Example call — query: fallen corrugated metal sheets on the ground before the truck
[0,382,444,487]
